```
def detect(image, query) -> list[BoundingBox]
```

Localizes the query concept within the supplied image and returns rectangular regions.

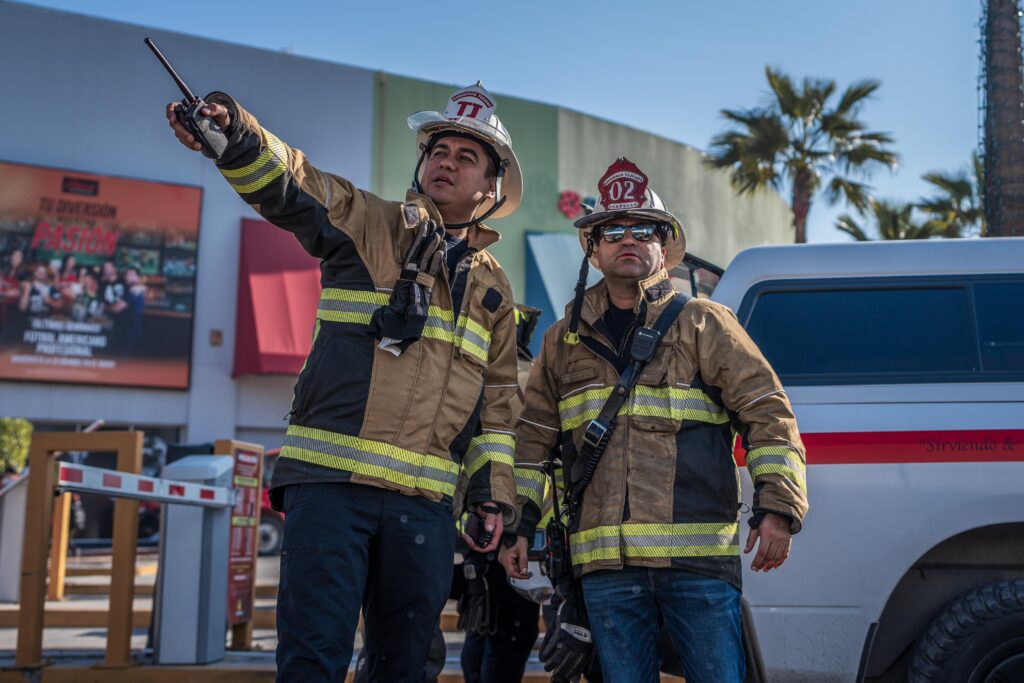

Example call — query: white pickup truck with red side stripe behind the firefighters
[684,239,1024,683]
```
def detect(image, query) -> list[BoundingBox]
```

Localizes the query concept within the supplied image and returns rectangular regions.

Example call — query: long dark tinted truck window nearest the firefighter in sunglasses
[746,283,980,384]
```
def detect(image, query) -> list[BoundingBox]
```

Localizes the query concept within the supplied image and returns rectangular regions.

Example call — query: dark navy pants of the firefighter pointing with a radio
[278,483,455,683]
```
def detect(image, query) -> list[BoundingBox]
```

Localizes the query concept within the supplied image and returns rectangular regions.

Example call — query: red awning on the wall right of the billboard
[231,219,321,377]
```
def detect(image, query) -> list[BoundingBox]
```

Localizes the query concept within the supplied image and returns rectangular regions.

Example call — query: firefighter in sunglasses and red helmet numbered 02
[501,159,807,683]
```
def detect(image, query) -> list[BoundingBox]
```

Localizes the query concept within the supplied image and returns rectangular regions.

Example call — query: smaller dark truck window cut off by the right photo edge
[974,283,1024,373]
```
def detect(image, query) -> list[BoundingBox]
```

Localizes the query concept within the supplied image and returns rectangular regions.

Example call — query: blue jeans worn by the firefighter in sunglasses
[583,566,746,683]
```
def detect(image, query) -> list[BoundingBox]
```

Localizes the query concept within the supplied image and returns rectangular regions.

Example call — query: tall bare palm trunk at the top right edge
[984,0,1024,237]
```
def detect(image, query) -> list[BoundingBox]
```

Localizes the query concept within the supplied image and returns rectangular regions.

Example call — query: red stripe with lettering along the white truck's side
[734,429,1024,467]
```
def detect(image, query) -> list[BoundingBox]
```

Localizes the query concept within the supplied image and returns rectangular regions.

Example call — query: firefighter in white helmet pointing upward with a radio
[166,83,522,683]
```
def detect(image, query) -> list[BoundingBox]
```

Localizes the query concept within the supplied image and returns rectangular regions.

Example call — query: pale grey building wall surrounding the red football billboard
[0,2,374,448]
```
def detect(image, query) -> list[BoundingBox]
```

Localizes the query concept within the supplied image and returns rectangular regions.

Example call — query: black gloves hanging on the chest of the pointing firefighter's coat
[370,220,445,355]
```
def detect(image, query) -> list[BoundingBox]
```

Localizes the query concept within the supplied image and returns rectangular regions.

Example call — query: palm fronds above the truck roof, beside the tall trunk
[918,153,987,238]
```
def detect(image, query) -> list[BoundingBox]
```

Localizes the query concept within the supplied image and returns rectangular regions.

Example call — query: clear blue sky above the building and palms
[16,0,981,242]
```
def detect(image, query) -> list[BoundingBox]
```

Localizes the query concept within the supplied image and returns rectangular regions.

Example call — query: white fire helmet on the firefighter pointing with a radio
[408,81,522,222]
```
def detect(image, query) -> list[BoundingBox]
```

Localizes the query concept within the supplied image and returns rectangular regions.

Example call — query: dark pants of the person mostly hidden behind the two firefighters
[461,561,541,683]
